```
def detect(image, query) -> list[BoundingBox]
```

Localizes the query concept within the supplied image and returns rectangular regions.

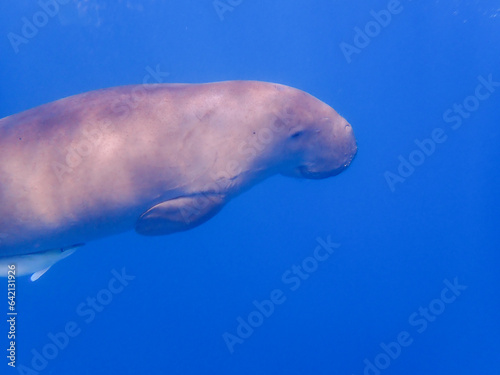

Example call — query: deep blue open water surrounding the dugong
[0,0,500,375]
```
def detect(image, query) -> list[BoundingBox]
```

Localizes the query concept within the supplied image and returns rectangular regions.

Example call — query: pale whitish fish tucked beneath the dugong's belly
[0,245,82,281]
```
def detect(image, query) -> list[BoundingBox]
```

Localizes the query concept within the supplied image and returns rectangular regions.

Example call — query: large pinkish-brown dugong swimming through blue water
[0,81,357,280]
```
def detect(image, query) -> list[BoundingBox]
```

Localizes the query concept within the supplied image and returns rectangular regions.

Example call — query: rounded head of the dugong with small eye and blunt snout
[273,85,357,179]
